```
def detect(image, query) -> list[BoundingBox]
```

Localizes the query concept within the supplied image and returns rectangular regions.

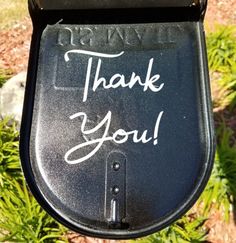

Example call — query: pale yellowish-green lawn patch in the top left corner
[0,0,28,29]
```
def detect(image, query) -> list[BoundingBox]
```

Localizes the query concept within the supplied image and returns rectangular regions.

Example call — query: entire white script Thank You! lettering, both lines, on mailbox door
[64,49,164,165]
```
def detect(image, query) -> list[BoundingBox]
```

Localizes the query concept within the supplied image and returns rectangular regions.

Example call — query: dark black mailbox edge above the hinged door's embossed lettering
[28,0,207,26]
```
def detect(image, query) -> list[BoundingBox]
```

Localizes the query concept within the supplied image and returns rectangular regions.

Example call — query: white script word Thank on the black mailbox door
[64,49,164,102]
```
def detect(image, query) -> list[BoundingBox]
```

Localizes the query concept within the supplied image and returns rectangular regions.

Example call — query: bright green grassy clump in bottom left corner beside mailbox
[0,177,64,243]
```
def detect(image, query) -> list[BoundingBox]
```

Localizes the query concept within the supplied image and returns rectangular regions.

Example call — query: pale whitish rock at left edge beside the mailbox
[0,72,27,123]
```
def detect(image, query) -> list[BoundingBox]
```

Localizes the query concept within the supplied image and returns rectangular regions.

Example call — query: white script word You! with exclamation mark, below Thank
[65,111,164,165]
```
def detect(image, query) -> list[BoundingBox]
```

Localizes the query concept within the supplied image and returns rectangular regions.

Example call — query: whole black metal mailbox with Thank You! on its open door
[20,0,214,239]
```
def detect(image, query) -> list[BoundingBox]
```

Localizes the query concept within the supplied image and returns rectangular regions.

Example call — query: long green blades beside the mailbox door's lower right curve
[199,124,236,220]
